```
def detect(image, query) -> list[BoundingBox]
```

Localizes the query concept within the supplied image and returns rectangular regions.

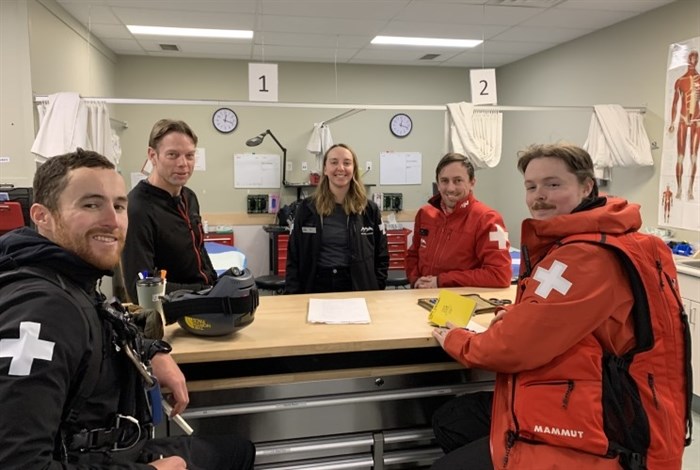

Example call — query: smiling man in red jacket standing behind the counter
[406,153,512,289]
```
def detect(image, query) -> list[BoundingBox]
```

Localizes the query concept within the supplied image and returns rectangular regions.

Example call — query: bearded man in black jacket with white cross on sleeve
[0,149,255,470]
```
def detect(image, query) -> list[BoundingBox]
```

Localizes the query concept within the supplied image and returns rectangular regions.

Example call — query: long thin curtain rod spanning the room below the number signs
[34,96,646,113]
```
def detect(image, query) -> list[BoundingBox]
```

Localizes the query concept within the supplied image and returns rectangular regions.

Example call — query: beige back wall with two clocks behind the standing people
[115,56,476,212]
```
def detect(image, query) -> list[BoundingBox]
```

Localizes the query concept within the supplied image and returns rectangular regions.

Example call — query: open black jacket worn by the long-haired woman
[285,197,389,294]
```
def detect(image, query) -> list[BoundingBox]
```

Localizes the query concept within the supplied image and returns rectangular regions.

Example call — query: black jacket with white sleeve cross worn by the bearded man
[0,228,151,469]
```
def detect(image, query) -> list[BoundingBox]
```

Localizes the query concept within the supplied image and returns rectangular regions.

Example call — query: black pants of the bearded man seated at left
[139,436,255,470]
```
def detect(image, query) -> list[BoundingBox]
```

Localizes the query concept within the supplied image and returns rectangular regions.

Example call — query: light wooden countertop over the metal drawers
[165,286,515,364]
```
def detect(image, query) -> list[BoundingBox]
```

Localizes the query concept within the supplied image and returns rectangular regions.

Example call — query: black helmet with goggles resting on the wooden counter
[163,268,259,336]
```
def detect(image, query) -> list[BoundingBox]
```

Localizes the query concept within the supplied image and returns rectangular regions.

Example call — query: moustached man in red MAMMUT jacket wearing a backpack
[433,145,688,470]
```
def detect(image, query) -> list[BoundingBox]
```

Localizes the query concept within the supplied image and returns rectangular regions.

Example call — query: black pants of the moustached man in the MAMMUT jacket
[432,392,493,470]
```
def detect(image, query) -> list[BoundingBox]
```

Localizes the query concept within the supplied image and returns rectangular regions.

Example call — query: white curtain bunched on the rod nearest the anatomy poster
[583,104,654,180]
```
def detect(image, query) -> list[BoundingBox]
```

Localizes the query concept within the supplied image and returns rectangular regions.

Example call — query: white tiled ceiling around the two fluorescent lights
[57,0,674,67]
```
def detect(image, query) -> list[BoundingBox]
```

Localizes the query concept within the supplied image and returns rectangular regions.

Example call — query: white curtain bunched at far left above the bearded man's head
[32,92,121,165]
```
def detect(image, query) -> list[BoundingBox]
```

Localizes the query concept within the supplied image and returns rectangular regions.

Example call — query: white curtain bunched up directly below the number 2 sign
[445,102,503,168]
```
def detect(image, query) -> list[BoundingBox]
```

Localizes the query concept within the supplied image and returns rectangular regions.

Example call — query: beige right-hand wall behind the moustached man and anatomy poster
[480,0,700,248]
